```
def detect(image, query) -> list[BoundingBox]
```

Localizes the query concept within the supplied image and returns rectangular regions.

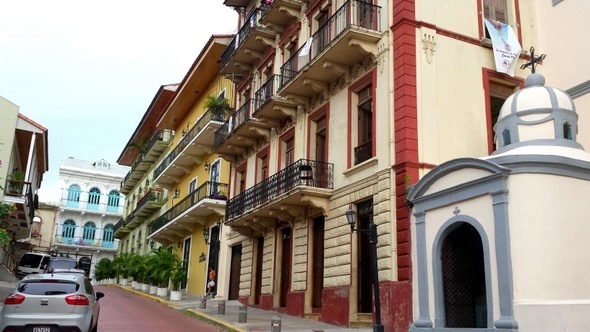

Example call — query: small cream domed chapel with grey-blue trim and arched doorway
[408,74,590,331]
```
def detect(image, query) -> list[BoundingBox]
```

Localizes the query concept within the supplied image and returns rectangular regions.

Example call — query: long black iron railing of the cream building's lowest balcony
[225,159,334,221]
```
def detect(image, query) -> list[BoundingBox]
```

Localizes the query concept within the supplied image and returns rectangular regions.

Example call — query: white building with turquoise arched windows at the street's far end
[51,158,129,276]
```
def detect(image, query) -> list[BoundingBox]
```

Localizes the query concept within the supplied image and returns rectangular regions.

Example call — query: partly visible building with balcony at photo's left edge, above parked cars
[0,97,49,273]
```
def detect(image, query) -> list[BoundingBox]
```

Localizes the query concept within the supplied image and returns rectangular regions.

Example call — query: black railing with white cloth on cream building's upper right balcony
[281,0,381,87]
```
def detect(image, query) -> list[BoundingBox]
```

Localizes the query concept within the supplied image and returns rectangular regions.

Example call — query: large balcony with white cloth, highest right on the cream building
[279,0,382,98]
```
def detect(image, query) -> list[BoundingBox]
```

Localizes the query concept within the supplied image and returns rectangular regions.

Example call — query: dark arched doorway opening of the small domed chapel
[441,223,487,328]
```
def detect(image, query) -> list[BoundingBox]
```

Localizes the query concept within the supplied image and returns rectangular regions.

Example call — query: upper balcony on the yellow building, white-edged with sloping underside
[154,110,225,188]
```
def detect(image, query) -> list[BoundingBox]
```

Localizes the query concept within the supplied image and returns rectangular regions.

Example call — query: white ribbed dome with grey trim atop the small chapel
[494,74,581,154]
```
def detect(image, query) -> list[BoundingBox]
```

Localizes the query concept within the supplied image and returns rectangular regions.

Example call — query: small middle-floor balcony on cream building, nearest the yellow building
[213,99,271,160]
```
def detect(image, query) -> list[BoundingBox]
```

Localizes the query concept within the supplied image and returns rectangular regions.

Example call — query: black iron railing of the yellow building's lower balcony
[149,181,228,234]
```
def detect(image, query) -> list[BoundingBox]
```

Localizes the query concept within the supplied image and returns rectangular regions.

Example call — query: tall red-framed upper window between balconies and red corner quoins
[354,85,373,165]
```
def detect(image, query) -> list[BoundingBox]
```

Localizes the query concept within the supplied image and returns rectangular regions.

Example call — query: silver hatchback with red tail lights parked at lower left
[0,273,104,332]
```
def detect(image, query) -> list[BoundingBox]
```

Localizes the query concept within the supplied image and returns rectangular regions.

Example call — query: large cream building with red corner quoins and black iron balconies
[214,0,583,331]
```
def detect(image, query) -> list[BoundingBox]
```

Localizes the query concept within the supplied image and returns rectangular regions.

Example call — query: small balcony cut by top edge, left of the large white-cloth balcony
[260,0,303,33]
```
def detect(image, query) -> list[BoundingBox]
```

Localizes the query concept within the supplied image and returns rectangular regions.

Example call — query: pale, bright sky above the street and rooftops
[0,0,237,202]
